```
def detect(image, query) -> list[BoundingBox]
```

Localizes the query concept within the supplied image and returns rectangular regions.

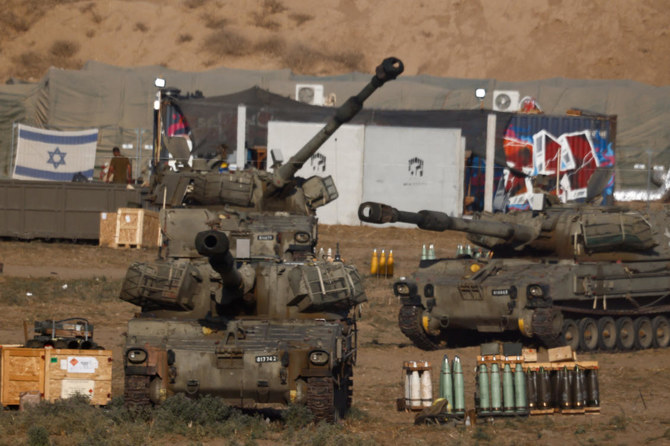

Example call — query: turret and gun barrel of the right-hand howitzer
[358,202,670,261]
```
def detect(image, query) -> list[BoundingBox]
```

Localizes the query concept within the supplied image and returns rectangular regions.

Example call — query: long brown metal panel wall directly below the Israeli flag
[0,180,141,240]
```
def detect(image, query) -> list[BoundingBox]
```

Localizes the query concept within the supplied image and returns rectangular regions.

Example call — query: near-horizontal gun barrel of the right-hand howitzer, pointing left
[358,201,536,243]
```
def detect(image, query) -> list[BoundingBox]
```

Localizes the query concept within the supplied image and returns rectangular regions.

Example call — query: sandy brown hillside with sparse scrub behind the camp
[0,0,670,85]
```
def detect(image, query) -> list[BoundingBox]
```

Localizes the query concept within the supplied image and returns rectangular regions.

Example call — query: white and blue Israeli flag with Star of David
[12,124,98,181]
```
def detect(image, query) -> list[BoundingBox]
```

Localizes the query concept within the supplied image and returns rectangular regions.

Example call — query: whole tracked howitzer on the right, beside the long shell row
[359,202,670,351]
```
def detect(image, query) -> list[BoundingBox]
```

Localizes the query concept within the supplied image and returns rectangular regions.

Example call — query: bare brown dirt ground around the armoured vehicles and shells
[0,226,670,445]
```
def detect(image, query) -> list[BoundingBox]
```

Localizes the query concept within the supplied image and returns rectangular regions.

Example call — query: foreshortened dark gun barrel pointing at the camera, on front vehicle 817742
[195,230,244,304]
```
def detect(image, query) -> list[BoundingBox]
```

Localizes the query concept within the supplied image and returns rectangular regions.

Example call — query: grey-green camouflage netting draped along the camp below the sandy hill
[0,62,670,189]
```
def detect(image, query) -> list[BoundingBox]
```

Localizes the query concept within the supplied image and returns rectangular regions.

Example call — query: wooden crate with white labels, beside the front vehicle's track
[44,348,112,406]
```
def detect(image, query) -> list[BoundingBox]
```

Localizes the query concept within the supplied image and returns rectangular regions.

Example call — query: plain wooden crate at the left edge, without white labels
[0,346,45,406]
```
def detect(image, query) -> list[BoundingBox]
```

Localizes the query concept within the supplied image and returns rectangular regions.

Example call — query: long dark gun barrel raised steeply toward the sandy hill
[268,57,405,192]
